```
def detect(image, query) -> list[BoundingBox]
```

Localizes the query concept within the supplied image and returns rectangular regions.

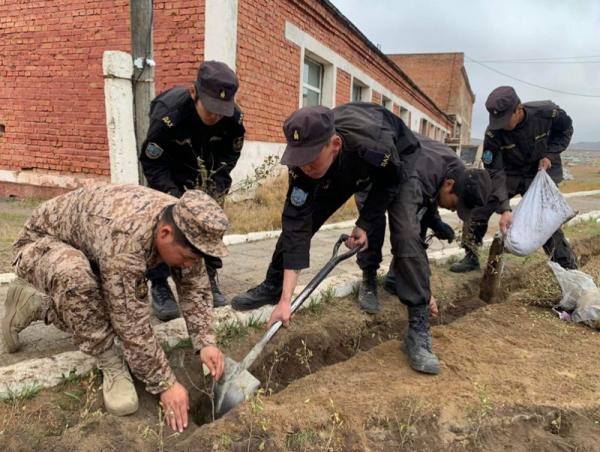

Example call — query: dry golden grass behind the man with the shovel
[225,173,357,234]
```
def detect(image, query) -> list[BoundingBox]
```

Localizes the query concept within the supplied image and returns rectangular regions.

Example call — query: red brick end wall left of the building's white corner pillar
[0,0,204,180]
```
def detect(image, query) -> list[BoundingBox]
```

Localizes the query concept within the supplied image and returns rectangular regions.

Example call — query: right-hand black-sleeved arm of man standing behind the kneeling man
[210,108,246,200]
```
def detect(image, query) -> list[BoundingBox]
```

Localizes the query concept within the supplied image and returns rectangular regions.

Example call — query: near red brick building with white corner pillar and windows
[0,0,452,196]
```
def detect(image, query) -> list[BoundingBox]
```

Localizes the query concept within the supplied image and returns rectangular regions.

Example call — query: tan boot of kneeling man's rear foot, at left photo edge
[2,280,45,353]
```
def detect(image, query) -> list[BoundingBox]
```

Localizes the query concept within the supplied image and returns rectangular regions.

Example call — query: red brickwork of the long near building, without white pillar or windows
[0,0,447,185]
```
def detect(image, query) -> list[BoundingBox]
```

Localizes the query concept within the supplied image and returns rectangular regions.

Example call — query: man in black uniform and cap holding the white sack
[450,86,577,273]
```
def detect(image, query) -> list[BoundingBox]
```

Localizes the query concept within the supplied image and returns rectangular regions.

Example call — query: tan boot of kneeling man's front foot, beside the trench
[96,348,138,416]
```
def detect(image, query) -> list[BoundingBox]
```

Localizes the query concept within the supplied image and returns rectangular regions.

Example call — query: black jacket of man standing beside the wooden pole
[140,87,245,201]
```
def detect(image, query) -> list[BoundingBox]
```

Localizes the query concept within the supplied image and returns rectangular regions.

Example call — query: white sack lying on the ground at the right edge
[548,262,600,329]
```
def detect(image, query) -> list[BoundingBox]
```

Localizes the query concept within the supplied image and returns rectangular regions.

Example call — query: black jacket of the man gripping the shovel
[282,102,418,269]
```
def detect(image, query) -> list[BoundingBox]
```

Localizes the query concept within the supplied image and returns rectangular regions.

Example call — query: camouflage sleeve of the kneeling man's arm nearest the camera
[99,254,176,394]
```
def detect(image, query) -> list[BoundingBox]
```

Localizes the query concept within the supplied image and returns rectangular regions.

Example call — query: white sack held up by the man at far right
[504,170,575,256]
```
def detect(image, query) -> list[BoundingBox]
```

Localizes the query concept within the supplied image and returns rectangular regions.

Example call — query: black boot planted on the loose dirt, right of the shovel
[404,304,440,374]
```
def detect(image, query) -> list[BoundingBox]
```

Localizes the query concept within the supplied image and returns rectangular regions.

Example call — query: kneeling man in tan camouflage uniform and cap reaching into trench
[2,185,228,431]
